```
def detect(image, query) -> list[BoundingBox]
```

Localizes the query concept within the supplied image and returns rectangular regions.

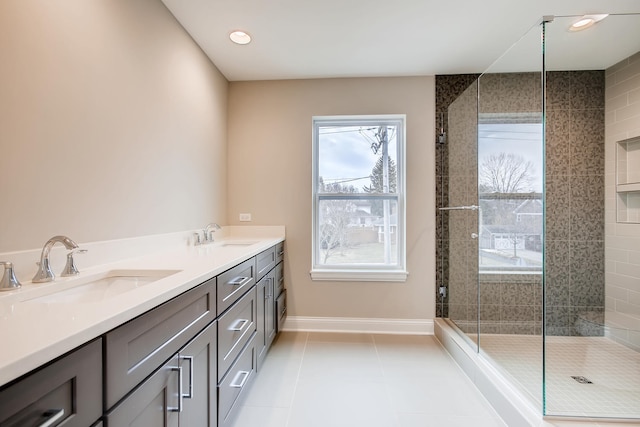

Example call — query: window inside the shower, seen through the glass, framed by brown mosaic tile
[478,114,544,274]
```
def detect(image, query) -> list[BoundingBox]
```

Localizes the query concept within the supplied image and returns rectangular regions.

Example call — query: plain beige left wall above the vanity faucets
[0,0,228,252]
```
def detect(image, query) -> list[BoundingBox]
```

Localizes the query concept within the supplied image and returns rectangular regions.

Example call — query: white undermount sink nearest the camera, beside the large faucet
[24,270,180,304]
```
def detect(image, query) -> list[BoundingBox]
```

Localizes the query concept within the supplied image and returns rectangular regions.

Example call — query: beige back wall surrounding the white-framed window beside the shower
[227,77,435,319]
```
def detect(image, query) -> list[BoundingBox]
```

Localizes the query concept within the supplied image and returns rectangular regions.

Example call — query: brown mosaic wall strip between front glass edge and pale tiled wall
[545,71,604,336]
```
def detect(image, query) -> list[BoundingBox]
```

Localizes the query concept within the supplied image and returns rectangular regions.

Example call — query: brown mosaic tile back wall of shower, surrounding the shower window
[436,71,604,335]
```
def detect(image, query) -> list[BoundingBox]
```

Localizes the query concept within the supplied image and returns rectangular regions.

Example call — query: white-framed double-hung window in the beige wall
[311,115,407,281]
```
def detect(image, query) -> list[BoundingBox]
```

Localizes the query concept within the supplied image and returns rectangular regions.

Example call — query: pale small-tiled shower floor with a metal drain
[480,334,640,418]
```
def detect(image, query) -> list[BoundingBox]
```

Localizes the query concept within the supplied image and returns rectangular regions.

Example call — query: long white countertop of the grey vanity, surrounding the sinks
[0,227,284,386]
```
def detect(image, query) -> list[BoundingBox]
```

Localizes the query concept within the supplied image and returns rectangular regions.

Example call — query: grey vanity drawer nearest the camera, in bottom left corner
[0,339,102,427]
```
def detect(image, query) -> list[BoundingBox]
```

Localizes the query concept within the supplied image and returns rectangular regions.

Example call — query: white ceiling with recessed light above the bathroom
[162,0,640,81]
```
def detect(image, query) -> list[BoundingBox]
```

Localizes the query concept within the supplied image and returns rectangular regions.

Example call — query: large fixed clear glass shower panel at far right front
[544,14,640,419]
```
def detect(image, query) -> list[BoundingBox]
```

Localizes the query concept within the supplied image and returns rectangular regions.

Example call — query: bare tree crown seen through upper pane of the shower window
[479,153,534,193]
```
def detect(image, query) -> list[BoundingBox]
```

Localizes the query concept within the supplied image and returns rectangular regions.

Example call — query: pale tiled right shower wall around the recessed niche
[605,52,640,351]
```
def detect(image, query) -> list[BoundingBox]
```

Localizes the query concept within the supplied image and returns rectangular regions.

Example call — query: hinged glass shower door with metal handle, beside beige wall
[440,81,478,349]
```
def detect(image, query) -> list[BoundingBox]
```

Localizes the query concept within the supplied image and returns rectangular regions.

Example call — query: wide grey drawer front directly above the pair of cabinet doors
[105,278,216,408]
